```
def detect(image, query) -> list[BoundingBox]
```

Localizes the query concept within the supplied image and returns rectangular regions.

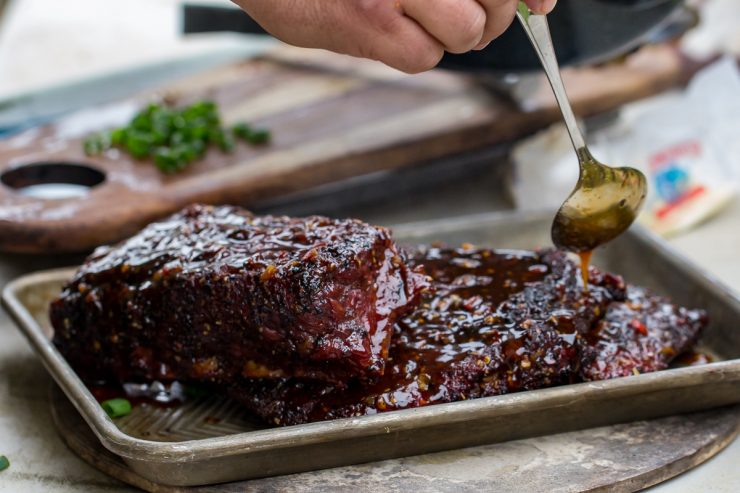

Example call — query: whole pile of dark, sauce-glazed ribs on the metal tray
[51,206,707,425]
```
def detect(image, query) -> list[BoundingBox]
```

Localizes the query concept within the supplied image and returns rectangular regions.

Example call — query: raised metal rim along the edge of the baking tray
[2,211,740,464]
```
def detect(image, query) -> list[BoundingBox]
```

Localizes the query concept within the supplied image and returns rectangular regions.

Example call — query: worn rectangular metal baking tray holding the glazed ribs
[3,213,740,486]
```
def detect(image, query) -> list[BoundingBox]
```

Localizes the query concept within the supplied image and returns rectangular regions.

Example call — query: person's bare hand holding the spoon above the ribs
[233,0,556,73]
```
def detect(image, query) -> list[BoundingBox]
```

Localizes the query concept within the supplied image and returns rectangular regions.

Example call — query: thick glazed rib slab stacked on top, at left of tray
[50,205,426,383]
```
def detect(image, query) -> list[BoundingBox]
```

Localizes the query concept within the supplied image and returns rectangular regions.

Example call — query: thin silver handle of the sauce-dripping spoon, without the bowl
[516,7,588,154]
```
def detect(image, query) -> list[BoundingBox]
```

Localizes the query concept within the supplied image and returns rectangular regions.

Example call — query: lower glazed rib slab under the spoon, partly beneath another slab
[227,248,706,425]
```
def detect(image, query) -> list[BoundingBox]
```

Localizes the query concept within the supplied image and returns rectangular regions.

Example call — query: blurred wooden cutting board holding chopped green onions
[0,45,694,253]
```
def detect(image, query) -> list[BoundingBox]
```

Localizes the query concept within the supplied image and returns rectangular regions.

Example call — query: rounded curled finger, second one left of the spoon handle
[400,0,486,53]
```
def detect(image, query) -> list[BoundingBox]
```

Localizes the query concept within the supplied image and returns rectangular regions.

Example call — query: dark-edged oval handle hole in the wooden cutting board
[0,162,105,200]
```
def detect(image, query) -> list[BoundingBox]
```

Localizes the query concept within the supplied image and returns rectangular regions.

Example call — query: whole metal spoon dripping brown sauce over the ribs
[517,2,647,253]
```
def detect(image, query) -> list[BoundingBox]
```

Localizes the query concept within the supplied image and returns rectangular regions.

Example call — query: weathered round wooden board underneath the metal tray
[51,386,740,493]
